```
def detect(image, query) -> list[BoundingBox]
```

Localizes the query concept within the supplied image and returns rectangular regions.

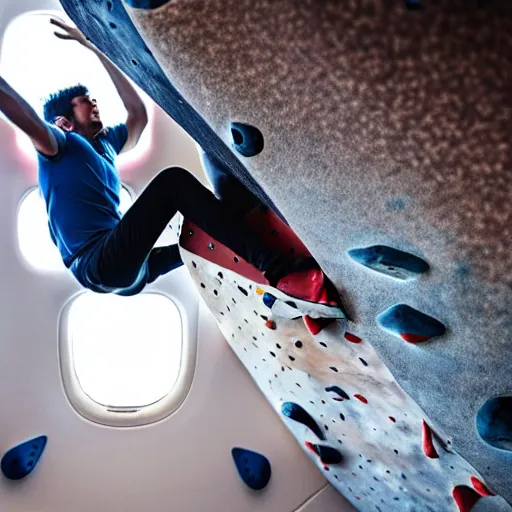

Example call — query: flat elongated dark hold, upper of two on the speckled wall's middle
[348,245,429,280]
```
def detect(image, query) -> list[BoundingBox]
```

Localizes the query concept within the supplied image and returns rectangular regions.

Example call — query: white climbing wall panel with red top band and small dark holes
[180,213,504,512]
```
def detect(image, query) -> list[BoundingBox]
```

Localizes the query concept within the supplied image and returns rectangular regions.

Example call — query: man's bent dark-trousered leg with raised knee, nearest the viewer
[96,167,296,288]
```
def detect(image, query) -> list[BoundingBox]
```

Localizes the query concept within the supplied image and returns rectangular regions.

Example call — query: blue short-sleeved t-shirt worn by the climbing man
[38,124,128,267]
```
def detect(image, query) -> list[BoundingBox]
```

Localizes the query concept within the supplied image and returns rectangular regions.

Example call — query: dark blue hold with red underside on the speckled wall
[377,304,446,343]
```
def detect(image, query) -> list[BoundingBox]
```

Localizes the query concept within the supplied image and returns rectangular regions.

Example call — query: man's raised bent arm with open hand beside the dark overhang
[51,18,148,152]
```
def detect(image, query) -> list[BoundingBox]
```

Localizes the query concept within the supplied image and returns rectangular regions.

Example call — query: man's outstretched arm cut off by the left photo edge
[0,76,58,156]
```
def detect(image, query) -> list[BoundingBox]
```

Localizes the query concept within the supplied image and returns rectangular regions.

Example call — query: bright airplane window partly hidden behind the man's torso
[18,186,133,272]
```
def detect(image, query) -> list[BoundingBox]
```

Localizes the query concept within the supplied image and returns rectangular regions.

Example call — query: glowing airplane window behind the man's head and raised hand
[0,12,154,164]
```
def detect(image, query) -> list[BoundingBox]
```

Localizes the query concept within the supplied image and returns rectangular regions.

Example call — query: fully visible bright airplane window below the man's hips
[67,292,183,408]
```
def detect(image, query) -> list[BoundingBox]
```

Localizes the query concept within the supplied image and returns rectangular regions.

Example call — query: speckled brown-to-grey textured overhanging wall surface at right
[58,0,512,510]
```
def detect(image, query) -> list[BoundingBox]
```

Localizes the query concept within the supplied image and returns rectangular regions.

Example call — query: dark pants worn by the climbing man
[72,167,286,295]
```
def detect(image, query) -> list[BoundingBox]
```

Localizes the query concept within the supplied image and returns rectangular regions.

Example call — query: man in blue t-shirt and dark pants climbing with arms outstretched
[0,19,321,295]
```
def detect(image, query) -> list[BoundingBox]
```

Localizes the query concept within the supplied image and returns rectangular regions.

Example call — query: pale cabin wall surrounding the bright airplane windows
[0,0,356,512]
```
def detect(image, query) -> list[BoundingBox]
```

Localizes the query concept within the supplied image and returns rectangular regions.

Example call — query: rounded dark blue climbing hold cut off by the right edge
[476,396,512,452]
